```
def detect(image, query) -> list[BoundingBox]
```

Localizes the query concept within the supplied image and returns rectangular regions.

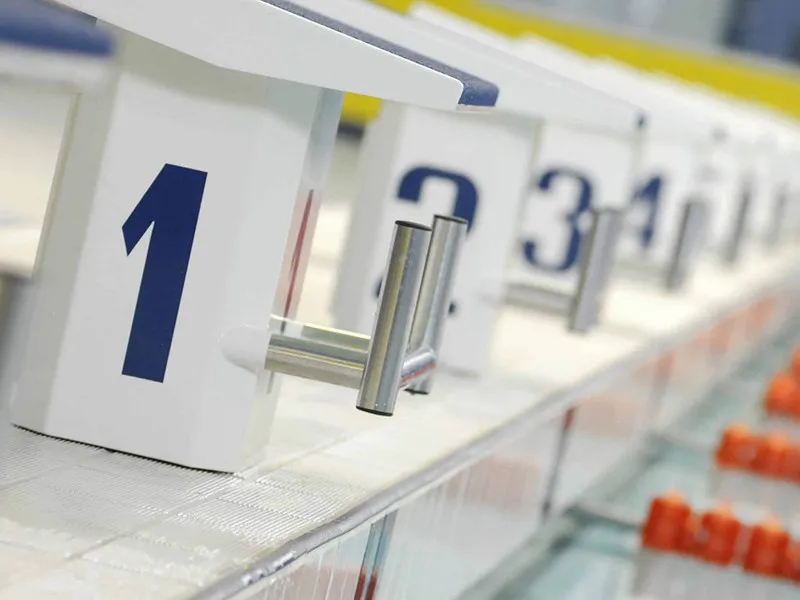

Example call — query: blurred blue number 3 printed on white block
[522,169,592,272]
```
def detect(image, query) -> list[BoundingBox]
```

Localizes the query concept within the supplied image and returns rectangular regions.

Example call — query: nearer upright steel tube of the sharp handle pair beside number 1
[356,221,431,416]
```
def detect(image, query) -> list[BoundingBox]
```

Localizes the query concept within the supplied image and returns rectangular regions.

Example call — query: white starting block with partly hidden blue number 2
[325,0,643,373]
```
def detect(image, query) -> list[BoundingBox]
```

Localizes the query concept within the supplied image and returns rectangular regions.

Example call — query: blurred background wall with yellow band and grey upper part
[344,0,800,128]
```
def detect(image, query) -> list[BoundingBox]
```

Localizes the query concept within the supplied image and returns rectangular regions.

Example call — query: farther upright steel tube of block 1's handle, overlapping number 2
[408,215,467,394]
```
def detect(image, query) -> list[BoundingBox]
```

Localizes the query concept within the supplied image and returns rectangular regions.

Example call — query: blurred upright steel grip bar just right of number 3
[568,208,623,333]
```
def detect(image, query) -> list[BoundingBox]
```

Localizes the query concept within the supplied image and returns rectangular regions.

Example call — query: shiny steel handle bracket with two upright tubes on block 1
[264,216,467,416]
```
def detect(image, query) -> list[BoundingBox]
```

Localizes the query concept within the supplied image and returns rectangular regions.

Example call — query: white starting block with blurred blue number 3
[512,38,644,289]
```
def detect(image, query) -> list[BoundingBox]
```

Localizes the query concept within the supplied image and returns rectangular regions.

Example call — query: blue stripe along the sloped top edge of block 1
[266,0,500,107]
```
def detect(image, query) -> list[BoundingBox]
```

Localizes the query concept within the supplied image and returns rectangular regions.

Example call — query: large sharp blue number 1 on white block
[122,164,207,382]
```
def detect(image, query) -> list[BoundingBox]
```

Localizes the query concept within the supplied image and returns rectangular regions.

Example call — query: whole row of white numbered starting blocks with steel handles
[0,0,800,597]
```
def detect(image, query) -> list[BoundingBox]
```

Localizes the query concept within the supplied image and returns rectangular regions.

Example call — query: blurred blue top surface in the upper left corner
[0,0,113,57]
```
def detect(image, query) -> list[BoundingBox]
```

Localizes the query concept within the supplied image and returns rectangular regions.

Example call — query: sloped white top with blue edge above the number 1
[50,0,499,110]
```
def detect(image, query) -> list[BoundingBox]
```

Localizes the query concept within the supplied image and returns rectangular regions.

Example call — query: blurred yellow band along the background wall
[343,0,800,124]
